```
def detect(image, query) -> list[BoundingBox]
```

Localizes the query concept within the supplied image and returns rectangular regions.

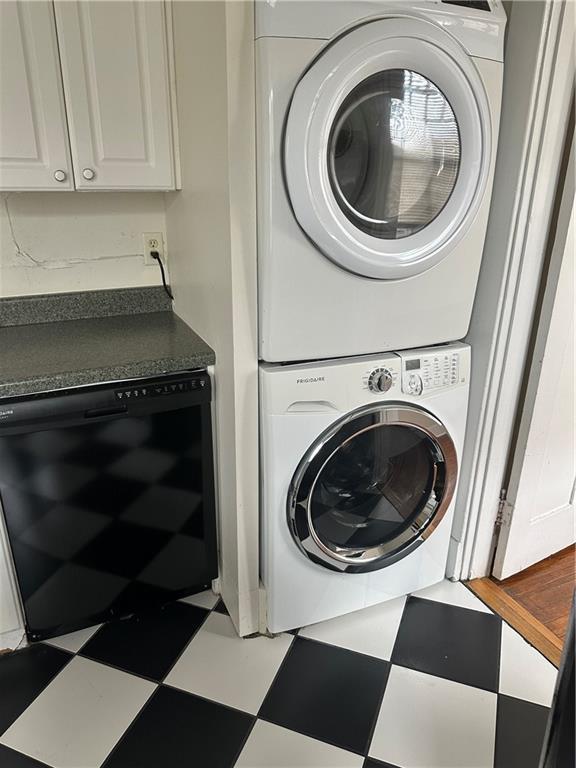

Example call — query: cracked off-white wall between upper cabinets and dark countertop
[0,192,166,297]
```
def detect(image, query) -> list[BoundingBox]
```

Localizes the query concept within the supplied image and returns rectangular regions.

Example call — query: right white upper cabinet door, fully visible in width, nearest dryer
[55,0,174,189]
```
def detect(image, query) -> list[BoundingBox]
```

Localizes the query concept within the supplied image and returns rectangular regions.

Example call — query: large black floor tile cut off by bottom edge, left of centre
[103,686,254,768]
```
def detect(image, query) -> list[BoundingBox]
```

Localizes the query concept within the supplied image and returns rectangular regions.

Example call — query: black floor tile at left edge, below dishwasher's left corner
[0,644,72,735]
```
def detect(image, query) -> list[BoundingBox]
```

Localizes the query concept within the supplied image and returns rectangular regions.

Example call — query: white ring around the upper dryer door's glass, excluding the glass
[285,19,492,279]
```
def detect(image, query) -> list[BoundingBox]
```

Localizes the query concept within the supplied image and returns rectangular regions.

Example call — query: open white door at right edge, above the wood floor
[493,130,576,579]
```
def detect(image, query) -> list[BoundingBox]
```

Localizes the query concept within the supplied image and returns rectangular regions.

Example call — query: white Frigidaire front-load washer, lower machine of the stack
[260,344,470,632]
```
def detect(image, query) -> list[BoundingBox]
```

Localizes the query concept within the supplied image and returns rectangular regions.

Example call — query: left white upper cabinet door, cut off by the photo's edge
[0,0,73,190]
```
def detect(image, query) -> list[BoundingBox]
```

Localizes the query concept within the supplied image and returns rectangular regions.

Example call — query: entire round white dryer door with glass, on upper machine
[284,18,491,279]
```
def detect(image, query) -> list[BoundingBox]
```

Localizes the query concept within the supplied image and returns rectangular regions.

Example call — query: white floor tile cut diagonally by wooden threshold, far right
[499,622,558,707]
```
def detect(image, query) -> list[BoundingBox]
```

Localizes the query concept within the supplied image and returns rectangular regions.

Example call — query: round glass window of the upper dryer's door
[328,69,460,239]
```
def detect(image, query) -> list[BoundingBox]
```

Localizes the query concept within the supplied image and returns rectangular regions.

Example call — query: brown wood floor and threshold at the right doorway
[468,545,576,666]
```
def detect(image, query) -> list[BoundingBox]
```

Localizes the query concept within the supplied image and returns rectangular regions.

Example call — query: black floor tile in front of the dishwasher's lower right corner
[80,603,209,681]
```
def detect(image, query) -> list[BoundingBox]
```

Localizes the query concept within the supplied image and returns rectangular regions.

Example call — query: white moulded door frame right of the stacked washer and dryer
[447,0,574,580]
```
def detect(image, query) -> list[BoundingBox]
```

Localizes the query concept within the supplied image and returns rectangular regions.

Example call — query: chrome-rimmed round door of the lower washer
[288,404,458,573]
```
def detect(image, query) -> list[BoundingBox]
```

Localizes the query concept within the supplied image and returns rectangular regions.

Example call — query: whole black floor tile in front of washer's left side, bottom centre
[258,637,390,754]
